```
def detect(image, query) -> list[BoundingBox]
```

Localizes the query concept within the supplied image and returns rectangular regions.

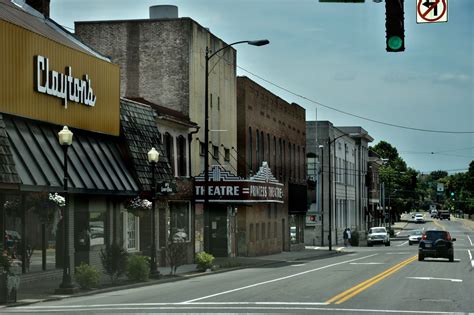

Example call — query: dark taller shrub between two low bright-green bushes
[100,243,128,282]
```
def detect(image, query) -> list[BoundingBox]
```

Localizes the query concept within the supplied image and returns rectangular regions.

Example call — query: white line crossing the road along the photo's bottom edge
[9,302,464,314]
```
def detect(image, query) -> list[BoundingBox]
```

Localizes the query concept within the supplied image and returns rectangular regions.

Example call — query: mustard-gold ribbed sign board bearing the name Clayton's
[0,20,120,136]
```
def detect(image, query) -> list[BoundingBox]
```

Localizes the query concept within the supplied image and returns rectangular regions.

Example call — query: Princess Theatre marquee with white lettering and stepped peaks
[194,162,284,203]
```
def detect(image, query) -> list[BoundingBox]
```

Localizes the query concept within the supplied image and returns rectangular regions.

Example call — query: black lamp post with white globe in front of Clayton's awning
[58,126,74,290]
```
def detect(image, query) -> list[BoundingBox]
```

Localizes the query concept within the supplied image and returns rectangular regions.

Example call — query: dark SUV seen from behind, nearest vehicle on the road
[418,230,456,261]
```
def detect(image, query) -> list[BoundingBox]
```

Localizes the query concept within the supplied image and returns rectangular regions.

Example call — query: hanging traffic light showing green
[385,0,405,52]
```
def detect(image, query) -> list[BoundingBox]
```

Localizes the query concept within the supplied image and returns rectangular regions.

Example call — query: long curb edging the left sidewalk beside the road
[7,250,345,309]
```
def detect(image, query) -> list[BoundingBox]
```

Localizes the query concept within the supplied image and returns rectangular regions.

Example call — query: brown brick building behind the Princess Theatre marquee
[237,77,306,256]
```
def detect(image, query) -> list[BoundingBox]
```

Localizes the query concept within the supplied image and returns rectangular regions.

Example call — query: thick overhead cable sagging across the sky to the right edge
[237,66,474,134]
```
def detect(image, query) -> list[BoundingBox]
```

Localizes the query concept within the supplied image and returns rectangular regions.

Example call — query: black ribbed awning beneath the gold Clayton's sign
[4,115,139,195]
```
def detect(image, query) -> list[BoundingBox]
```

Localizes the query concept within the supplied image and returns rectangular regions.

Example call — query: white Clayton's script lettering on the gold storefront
[35,56,96,108]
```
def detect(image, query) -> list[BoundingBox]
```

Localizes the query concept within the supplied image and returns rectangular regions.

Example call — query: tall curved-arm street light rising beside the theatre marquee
[203,39,270,251]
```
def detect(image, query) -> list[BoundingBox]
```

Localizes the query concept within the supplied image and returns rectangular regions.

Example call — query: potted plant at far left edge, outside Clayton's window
[0,251,20,304]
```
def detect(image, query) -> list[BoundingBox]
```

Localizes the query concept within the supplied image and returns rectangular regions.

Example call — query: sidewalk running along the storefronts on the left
[9,247,342,309]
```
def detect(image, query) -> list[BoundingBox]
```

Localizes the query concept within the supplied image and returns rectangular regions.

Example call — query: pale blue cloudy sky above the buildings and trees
[51,0,474,172]
